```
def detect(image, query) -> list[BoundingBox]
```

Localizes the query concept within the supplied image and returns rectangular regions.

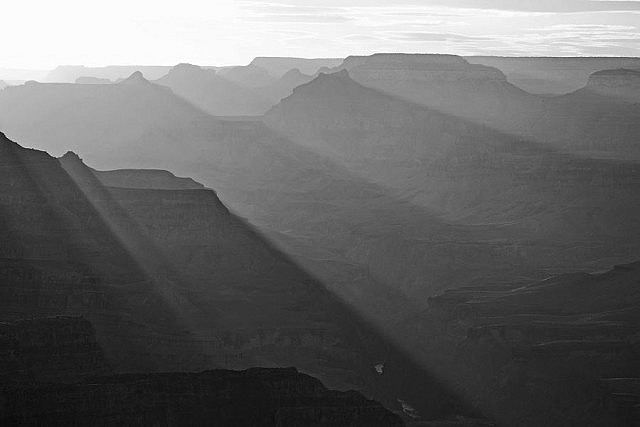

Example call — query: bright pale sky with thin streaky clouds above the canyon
[0,0,640,69]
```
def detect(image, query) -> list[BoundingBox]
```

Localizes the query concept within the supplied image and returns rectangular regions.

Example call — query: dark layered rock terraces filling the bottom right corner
[405,263,640,426]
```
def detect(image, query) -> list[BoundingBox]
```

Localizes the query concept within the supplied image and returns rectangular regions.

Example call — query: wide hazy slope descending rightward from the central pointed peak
[265,71,640,298]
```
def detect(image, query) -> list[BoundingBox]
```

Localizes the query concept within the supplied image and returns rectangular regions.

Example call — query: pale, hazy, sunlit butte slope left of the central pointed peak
[156,64,271,116]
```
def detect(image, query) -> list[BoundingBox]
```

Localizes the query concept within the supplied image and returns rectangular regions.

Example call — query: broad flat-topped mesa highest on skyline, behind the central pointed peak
[328,54,539,131]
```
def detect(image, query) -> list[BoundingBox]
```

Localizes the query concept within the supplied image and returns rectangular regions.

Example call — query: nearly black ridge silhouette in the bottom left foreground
[0,317,403,426]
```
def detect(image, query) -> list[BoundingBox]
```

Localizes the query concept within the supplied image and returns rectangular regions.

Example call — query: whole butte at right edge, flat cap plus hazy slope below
[529,69,640,161]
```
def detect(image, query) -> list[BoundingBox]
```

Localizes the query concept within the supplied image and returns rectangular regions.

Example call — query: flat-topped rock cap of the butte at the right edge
[584,68,640,101]
